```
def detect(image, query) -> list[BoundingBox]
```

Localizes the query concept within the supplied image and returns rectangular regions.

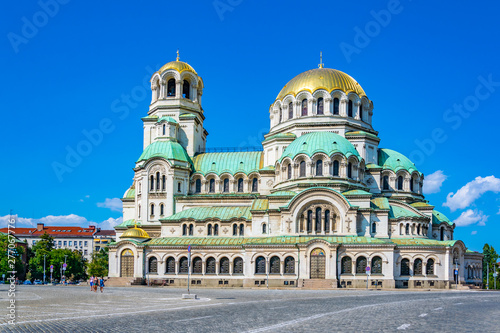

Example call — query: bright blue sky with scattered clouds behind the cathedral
[0,0,500,250]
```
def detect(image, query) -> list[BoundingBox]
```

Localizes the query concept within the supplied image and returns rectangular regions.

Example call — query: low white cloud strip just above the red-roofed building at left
[0,214,118,230]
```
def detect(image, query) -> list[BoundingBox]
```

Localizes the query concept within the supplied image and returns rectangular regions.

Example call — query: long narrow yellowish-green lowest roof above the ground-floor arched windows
[145,236,391,246]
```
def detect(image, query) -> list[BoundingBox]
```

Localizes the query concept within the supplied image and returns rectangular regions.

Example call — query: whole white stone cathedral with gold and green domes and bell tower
[109,56,482,288]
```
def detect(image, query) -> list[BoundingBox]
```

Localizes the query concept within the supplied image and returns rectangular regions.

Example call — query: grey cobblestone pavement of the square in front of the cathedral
[0,285,500,333]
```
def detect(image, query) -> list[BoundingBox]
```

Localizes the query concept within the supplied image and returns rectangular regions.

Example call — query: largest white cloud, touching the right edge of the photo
[443,176,500,212]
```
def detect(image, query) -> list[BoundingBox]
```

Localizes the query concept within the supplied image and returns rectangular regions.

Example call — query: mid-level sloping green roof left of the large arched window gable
[160,206,252,221]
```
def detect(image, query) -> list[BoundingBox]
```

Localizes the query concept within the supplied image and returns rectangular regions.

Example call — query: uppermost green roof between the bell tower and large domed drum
[193,151,264,175]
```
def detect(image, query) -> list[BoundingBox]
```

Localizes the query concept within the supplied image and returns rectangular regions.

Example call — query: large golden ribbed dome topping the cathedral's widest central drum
[276,68,366,99]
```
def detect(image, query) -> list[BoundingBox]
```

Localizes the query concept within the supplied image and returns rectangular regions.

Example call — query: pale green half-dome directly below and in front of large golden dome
[280,132,361,161]
